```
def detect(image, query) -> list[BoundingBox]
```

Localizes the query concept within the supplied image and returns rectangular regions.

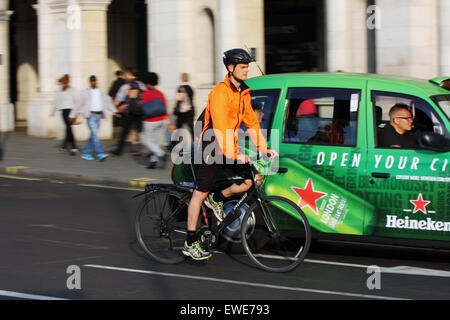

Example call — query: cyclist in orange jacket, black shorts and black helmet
[183,49,278,260]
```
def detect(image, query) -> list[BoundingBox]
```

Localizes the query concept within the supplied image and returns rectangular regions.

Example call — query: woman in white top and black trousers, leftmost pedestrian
[52,74,79,156]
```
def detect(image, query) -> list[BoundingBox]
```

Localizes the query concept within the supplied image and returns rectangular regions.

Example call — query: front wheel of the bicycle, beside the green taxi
[241,196,311,272]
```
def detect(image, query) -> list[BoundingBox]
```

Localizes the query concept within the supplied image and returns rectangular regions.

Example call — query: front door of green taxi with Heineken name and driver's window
[366,81,450,240]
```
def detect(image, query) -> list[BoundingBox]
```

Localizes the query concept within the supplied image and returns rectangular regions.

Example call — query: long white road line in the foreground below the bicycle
[84,264,408,300]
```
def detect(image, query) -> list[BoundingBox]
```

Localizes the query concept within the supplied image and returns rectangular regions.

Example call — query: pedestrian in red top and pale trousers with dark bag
[141,72,176,169]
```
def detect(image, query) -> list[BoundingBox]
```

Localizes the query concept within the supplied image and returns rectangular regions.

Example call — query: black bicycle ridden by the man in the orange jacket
[134,156,311,272]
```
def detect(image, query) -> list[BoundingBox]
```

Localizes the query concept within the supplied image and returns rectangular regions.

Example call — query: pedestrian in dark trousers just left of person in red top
[111,68,146,156]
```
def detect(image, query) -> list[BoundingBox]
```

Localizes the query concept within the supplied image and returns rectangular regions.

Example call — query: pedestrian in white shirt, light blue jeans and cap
[69,75,117,161]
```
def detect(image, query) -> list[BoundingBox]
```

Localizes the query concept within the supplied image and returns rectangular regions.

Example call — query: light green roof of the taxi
[247,72,449,96]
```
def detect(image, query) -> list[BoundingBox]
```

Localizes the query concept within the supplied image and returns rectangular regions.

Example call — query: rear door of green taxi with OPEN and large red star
[265,76,373,235]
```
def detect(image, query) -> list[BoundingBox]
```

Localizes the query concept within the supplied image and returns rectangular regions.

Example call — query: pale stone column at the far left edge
[0,10,15,132]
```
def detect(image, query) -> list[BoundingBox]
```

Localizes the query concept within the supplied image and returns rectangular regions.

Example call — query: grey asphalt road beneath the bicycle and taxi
[0,177,450,306]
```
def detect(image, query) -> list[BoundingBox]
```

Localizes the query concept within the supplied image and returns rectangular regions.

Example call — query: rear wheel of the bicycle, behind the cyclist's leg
[135,190,190,264]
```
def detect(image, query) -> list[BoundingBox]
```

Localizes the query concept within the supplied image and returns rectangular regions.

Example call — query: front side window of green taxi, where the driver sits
[372,91,446,149]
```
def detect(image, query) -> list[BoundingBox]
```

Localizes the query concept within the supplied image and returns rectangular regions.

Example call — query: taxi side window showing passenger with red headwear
[283,88,361,146]
